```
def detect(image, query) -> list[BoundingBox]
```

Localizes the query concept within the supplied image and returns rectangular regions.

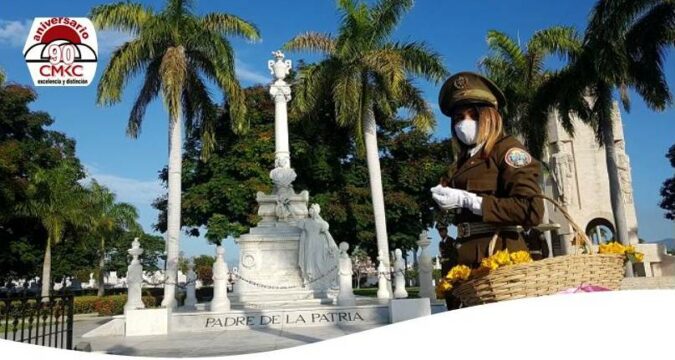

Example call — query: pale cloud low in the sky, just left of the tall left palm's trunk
[84,165,166,207]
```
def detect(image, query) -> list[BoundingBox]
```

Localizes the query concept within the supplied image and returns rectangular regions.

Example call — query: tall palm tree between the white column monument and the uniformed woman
[284,0,447,278]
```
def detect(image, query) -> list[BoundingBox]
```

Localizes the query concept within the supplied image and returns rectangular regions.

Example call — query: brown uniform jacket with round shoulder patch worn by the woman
[448,136,544,267]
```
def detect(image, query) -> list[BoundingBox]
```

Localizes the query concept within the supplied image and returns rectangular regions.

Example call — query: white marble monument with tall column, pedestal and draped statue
[232,51,338,304]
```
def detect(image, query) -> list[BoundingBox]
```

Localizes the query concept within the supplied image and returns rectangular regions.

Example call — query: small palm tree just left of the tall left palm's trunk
[87,180,140,296]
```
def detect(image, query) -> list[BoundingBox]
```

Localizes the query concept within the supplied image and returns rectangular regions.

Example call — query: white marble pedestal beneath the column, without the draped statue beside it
[230,191,337,308]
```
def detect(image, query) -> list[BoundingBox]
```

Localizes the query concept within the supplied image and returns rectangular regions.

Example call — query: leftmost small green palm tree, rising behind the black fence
[16,162,86,296]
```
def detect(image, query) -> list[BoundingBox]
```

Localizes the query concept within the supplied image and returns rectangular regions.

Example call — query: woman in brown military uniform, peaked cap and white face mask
[431,72,544,267]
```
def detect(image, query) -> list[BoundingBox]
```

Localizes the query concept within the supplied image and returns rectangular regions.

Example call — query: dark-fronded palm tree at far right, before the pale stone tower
[533,0,675,276]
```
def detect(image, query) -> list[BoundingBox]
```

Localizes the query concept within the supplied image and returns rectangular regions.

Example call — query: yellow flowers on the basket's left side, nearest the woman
[436,249,532,298]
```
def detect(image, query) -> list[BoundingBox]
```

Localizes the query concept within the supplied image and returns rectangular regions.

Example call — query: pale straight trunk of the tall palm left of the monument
[162,116,183,308]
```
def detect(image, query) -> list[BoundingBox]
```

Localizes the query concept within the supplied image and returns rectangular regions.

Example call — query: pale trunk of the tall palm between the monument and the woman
[363,107,392,297]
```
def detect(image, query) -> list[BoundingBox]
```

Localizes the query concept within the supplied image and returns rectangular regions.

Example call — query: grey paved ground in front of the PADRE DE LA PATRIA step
[73,317,381,357]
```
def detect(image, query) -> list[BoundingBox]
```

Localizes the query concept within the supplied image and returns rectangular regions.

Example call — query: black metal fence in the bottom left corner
[0,294,73,349]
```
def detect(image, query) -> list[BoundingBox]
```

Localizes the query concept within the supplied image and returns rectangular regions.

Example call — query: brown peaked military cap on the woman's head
[438,71,506,116]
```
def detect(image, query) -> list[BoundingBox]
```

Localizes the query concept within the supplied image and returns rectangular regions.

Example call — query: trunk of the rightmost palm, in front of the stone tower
[600,112,633,277]
